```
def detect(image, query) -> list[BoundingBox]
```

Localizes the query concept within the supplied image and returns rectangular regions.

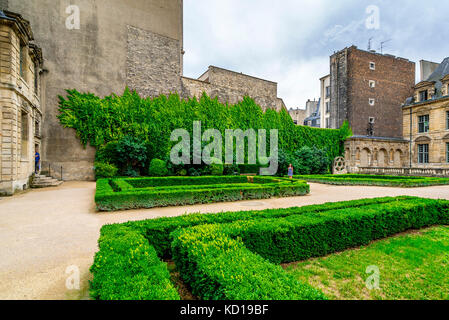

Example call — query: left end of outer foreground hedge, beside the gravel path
[90,225,180,300]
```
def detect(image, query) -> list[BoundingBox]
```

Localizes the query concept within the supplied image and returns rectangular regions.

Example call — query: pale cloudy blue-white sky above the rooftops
[184,0,449,108]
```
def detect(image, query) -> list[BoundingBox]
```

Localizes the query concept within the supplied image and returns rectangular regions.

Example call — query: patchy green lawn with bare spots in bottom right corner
[286,226,449,300]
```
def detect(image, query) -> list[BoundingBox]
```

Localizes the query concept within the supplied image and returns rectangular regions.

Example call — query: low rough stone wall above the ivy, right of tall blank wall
[181,66,286,111]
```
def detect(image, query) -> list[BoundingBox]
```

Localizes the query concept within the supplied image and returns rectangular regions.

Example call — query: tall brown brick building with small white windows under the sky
[323,46,415,138]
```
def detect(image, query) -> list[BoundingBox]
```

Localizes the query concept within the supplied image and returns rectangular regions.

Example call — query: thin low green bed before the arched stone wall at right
[294,174,449,188]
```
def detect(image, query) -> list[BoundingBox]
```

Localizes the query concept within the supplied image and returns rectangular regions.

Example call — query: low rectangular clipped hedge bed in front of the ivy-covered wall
[95,176,310,211]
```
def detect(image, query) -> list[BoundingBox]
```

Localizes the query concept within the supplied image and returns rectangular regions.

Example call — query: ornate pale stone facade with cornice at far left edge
[0,11,43,195]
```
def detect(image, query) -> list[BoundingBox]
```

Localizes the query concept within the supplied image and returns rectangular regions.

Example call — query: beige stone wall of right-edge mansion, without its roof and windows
[403,97,449,168]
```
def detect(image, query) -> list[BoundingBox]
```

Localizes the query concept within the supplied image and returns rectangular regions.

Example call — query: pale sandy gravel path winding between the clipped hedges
[0,182,449,299]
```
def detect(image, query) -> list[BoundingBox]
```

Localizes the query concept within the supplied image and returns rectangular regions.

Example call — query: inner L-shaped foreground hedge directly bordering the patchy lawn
[172,199,449,300]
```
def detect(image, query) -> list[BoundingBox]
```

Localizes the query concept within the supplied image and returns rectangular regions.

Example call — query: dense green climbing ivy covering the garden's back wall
[58,89,352,165]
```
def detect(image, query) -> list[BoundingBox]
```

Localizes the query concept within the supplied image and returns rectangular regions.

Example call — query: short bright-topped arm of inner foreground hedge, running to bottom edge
[172,225,326,300]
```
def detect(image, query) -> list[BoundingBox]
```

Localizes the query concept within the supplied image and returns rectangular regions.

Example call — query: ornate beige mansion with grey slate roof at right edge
[402,58,449,169]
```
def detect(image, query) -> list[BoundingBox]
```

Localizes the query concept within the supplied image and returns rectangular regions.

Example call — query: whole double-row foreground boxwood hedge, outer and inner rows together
[91,197,449,300]
